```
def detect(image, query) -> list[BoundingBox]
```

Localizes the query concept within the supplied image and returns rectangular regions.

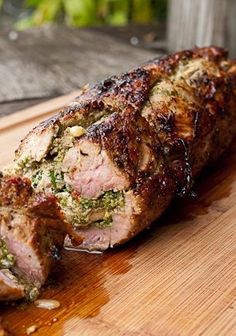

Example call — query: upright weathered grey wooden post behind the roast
[167,0,236,58]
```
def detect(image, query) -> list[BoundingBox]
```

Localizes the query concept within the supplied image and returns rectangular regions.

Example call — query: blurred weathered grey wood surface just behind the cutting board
[0,26,160,108]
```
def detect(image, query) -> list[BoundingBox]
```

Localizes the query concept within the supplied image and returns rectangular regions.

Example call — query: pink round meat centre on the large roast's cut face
[63,139,129,198]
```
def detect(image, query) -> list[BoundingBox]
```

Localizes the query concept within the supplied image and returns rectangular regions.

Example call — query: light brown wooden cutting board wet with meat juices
[0,92,236,336]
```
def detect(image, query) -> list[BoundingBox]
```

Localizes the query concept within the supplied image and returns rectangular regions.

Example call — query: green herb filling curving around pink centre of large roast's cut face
[13,124,125,228]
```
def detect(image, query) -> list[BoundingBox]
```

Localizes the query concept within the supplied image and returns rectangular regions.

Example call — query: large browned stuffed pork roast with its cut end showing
[10,47,236,250]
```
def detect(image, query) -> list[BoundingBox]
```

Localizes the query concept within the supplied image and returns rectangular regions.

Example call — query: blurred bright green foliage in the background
[15,0,167,29]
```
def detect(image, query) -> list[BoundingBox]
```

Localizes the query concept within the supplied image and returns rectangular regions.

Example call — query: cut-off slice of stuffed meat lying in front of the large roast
[0,176,66,300]
